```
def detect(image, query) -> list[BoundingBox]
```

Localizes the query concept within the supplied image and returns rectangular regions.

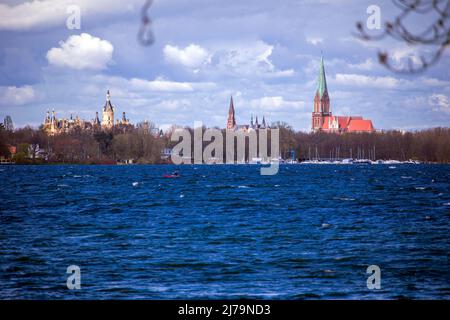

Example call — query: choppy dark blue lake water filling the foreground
[0,165,450,299]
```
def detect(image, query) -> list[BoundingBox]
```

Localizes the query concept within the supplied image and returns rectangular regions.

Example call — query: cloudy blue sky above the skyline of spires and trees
[0,0,450,131]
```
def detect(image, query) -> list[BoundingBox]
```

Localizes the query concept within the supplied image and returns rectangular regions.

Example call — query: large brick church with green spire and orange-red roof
[312,57,375,133]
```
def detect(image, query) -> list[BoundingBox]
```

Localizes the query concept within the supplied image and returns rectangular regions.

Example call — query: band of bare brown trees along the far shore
[0,123,450,164]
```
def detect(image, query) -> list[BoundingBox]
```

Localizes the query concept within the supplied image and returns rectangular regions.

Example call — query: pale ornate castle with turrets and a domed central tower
[43,90,133,135]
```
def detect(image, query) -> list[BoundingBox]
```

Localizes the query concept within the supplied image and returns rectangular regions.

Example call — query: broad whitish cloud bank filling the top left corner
[0,0,142,30]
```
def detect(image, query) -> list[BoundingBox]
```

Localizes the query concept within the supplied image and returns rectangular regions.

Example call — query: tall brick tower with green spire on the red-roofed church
[312,57,331,131]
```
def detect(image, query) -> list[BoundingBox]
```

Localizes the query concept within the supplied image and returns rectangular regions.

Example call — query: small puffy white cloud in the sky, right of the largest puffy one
[164,44,211,69]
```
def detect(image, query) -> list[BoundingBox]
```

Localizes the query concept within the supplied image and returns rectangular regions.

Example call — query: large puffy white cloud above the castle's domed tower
[47,33,114,70]
